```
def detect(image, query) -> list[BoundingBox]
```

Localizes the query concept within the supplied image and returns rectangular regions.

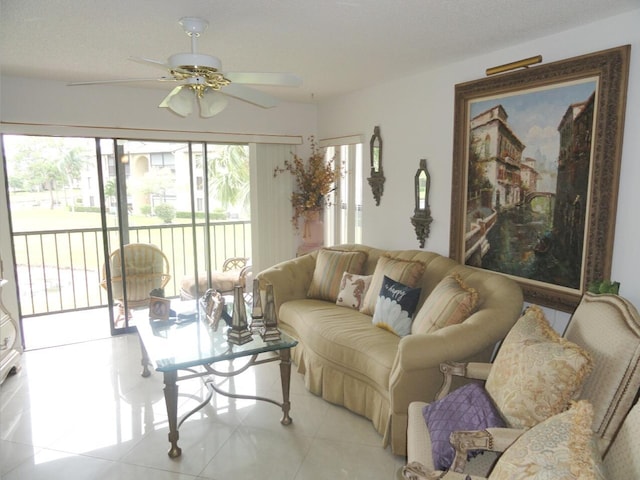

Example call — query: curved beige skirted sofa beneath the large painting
[257,245,523,455]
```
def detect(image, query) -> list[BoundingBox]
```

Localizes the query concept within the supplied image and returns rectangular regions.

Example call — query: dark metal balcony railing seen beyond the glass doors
[13,220,251,317]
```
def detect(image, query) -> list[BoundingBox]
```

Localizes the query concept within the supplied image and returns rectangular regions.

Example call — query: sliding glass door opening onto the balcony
[3,135,251,348]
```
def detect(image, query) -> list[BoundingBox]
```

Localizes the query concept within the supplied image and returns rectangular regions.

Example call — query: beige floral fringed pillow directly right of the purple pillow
[485,305,591,428]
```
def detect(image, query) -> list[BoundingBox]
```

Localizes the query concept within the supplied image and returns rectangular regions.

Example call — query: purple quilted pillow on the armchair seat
[422,383,506,470]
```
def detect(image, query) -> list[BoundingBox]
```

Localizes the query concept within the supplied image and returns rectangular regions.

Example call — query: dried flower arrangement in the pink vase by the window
[273,136,342,230]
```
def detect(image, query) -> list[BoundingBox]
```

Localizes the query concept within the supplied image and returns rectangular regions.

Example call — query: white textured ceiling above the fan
[0,0,640,102]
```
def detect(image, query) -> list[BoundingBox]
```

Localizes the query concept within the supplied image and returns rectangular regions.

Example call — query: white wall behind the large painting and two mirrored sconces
[318,9,640,316]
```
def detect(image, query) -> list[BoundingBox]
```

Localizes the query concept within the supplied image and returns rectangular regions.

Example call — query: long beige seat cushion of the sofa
[279,299,400,396]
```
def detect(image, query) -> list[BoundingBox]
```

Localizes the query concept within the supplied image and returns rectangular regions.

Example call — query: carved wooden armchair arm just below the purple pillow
[449,428,525,473]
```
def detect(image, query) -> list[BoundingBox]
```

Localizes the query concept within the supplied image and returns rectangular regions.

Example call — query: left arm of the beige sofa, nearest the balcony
[256,252,316,312]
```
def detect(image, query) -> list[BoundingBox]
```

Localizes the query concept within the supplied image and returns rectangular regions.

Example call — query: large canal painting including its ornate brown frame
[450,45,630,312]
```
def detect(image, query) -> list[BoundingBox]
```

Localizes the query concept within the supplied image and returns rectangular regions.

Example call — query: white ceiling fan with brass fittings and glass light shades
[68,17,302,118]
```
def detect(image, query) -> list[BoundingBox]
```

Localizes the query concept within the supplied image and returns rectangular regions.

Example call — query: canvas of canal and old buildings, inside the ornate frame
[465,81,595,288]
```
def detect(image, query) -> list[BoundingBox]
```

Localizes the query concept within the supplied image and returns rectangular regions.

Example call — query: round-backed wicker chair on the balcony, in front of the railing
[100,243,171,326]
